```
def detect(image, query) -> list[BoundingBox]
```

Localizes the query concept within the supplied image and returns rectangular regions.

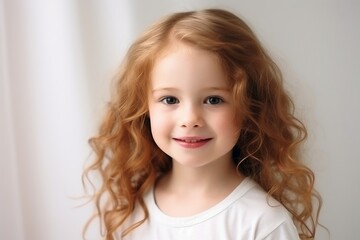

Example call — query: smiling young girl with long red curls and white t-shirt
[85,9,321,240]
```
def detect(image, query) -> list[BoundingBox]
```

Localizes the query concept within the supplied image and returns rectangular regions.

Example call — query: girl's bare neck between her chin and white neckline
[155,158,244,217]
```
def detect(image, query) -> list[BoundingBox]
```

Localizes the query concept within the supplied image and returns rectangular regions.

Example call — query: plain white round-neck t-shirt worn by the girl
[117,178,299,240]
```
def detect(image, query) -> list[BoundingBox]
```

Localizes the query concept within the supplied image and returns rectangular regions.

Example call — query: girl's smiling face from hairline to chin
[148,43,240,167]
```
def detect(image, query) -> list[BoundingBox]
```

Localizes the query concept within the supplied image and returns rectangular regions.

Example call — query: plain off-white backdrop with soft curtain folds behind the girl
[0,0,360,240]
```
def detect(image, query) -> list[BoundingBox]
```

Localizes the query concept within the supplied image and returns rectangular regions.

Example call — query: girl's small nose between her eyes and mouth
[180,106,204,128]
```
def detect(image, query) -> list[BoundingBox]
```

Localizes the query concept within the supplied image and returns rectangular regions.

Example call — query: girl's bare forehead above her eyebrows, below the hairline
[150,43,228,89]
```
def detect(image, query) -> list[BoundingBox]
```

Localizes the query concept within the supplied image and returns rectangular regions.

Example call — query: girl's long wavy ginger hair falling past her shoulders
[83,9,321,240]
